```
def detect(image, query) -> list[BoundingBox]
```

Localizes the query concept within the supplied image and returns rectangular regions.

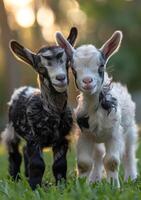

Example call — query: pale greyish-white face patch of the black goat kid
[41,53,68,92]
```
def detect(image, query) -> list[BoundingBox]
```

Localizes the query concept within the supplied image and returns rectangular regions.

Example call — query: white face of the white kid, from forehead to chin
[73,45,102,94]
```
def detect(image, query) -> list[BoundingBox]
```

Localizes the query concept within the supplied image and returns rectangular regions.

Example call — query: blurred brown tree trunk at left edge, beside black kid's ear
[0,0,20,97]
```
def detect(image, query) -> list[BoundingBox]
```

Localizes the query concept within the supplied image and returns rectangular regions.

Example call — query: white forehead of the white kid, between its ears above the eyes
[73,45,101,66]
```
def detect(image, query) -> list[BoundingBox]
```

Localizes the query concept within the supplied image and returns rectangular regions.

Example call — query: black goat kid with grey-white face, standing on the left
[2,28,77,189]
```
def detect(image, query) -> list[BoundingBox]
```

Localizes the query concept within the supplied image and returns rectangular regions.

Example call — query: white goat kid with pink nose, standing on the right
[56,31,137,187]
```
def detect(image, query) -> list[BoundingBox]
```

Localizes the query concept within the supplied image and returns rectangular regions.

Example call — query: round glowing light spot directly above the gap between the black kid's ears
[37,7,55,28]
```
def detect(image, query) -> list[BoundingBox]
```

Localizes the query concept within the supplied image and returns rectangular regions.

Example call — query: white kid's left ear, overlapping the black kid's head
[56,32,73,58]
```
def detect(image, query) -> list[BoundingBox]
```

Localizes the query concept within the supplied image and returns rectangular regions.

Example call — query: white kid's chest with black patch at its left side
[77,107,116,142]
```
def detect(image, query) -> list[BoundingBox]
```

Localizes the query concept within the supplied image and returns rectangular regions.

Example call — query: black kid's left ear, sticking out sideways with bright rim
[9,40,36,66]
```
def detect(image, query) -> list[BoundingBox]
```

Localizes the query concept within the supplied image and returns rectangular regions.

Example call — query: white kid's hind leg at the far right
[123,125,137,181]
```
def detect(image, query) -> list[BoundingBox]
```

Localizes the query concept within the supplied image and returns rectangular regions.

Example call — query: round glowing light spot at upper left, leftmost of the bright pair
[15,7,35,28]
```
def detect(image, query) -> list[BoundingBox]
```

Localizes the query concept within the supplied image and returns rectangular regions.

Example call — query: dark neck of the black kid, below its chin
[39,77,67,112]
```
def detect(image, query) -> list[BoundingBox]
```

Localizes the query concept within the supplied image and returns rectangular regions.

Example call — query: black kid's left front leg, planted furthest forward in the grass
[26,142,45,190]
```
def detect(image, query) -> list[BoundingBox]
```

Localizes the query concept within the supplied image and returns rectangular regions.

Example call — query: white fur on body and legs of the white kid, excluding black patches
[76,68,137,187]
